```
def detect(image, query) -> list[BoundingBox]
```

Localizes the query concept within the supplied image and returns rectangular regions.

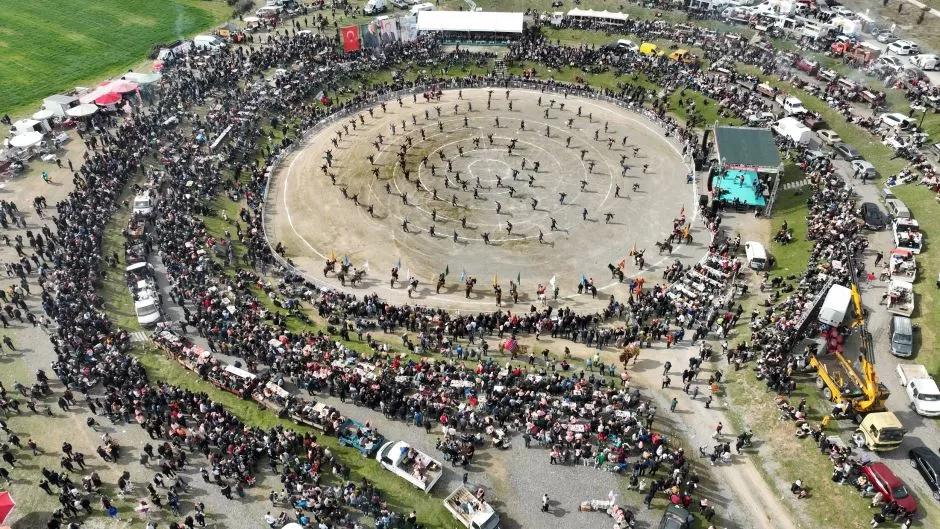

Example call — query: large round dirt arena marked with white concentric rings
[268,89,707,309]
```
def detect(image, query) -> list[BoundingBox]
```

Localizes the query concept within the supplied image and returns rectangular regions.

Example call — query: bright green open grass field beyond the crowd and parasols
[0,0,232,114]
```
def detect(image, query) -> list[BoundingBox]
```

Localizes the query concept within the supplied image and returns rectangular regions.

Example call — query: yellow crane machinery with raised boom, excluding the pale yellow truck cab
[809,282,891,419]
